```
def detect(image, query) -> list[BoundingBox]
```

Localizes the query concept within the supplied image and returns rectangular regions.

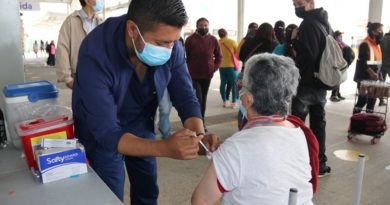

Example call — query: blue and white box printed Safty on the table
[36,148,88,183]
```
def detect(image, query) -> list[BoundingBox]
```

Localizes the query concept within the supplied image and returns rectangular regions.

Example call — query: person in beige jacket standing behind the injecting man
[56,0,104,89]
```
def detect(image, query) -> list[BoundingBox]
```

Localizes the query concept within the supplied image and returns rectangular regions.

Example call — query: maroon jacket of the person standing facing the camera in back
[185,33,222,80]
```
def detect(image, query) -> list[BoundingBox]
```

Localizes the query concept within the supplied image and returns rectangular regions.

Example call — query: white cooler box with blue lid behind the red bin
[3,81,58,148]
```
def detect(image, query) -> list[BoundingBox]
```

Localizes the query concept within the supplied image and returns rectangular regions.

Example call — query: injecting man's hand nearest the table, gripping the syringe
[164,129,201,160]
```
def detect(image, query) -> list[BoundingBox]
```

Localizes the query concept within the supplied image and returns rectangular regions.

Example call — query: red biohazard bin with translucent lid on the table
[15,115,74,170]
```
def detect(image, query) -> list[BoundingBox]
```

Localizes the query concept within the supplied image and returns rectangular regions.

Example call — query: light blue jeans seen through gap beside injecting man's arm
[158,89,172,139]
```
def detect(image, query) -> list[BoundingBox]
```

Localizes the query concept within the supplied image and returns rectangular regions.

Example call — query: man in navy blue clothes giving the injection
[72,0,219,205]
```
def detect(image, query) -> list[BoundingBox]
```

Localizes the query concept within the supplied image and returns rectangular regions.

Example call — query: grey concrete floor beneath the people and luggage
[25,58,390,205]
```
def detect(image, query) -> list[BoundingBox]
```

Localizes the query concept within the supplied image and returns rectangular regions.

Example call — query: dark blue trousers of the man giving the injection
[87,143,159,205]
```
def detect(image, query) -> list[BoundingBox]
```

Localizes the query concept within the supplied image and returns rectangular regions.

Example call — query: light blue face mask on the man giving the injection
[131,26,172,66]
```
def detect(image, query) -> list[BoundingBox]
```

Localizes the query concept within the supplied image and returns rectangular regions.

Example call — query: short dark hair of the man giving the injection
[126,0,188,32]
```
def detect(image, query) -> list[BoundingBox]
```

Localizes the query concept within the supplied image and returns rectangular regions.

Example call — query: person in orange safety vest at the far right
[353,22,383,114]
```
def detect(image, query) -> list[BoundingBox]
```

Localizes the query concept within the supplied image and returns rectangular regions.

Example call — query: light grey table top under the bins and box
[0,147,122,205]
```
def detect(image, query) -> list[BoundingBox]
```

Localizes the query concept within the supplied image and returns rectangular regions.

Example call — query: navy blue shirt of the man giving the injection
[72,15,201,151]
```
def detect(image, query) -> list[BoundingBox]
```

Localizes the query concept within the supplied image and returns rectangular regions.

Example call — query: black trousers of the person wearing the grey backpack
[291,88,328,171]
